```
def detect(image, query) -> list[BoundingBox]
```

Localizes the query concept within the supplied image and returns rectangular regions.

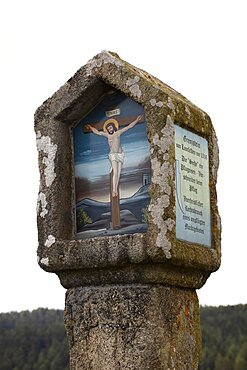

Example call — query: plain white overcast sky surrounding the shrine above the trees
[0,0,247,312]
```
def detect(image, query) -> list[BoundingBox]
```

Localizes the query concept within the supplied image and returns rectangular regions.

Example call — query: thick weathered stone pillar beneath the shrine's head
[65,284,201,370]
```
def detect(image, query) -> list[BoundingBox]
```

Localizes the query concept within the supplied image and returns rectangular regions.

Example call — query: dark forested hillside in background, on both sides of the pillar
[0,305,247,370]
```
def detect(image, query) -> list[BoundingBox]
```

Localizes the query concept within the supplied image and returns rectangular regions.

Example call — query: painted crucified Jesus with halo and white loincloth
[87,115,143,197]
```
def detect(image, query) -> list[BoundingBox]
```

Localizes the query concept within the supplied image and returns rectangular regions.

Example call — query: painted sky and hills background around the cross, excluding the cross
[73,91,151,238]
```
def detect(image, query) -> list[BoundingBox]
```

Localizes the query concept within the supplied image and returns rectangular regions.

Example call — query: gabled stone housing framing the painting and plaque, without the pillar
[35,51,221,288]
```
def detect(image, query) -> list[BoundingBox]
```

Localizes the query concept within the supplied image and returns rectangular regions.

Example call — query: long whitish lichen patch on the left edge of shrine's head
[36,131,57,187]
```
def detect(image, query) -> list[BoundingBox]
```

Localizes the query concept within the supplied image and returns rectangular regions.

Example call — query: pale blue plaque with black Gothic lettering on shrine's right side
[175,125,211,247]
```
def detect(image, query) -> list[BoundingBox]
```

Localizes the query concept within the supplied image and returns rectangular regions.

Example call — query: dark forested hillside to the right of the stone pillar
[199,305,247,370]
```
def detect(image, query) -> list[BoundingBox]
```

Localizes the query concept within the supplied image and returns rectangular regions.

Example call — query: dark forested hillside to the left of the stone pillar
[0,308,69,370]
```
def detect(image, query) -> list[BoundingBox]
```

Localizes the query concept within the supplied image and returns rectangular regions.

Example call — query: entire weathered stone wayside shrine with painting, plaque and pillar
[35,51,221,370]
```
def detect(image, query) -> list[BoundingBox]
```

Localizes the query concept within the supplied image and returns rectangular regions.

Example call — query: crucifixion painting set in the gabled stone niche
[72,90,151,239]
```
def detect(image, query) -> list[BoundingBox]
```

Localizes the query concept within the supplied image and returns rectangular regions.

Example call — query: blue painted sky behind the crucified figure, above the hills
[73,91,149,181]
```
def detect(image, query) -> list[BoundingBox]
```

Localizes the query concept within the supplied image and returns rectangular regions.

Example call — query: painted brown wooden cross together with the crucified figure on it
[84,115,144,229]
